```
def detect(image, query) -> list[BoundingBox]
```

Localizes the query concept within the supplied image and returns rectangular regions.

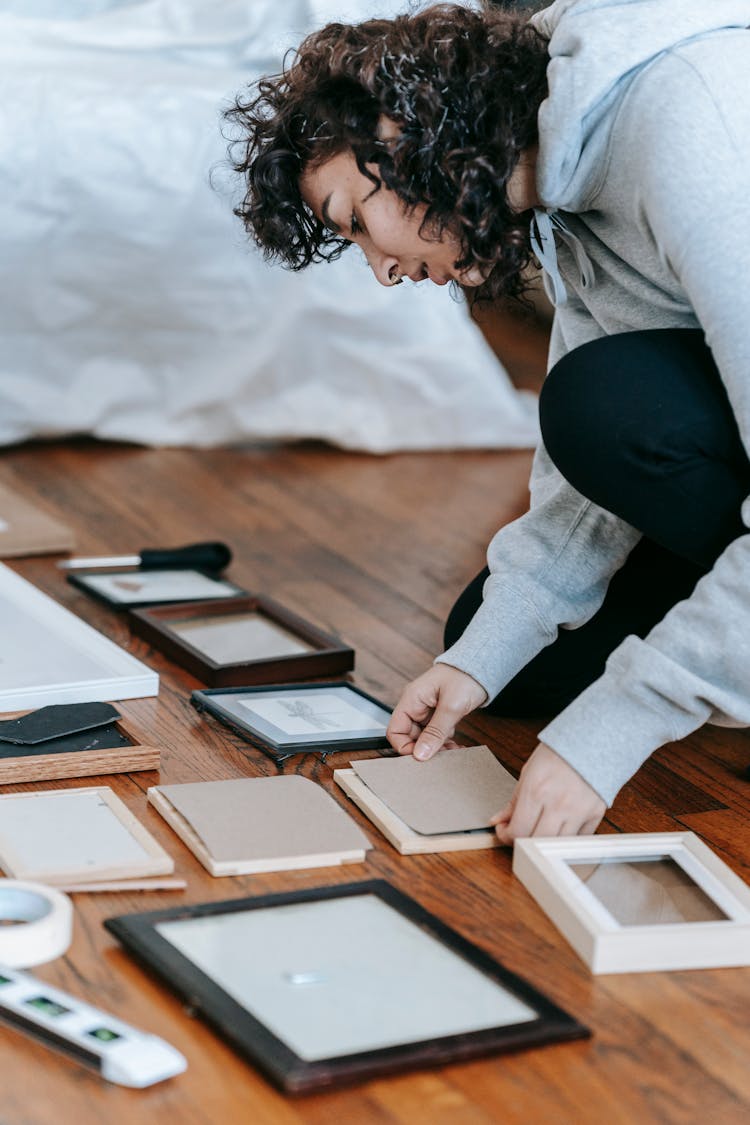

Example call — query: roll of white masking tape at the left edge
[0,879,73,969]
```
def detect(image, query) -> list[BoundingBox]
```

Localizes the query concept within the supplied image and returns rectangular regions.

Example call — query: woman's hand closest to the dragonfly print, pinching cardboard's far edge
[387,664,487,762]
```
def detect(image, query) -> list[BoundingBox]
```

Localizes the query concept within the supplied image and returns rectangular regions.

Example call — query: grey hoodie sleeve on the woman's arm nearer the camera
[532,52,750,803]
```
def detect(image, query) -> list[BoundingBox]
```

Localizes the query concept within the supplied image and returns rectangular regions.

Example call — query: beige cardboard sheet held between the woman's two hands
[352,746,516,835]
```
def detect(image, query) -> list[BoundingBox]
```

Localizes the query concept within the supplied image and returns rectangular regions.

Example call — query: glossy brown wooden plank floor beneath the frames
[0,308,750,1125]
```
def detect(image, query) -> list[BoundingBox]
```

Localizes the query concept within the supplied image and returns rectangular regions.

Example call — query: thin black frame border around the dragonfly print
[190,680,395,764]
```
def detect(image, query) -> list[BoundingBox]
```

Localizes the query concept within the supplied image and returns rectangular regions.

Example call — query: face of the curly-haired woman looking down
[299,152,484,286]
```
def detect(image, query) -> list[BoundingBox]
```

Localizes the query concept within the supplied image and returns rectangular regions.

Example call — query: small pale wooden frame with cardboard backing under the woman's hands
[334,746,516,855]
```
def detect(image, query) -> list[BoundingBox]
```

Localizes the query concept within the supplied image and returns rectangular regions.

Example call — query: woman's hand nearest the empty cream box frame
[490,743,607,844]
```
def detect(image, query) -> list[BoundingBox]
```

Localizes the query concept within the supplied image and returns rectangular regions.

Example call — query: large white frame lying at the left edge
[0,564,159,712]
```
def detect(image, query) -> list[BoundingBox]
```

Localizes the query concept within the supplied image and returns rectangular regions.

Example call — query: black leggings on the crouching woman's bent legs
[445,329,750,718]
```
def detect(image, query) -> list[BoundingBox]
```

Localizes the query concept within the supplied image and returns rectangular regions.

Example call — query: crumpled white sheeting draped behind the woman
[0,0,536,451]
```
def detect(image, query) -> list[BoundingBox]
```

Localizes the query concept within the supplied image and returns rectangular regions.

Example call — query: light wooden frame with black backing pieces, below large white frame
[0,703,161,785]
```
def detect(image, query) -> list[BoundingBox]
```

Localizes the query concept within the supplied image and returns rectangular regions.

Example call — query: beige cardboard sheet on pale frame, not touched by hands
[157,774,371,863]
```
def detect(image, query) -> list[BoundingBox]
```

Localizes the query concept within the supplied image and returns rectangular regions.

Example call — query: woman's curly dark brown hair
[225,3,549,299]
